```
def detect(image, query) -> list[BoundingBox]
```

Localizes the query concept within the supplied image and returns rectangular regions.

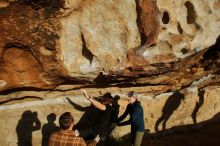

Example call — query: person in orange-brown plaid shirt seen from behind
[49,112,100,146]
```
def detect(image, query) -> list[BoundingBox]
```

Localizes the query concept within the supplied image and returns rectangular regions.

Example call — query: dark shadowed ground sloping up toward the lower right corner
[142,123,220,146]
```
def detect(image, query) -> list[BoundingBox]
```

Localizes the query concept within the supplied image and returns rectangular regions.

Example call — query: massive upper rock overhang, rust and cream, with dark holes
[0,0,220,90]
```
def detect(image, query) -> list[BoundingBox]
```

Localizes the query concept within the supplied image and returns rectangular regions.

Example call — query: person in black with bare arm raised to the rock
[81,89,114,143]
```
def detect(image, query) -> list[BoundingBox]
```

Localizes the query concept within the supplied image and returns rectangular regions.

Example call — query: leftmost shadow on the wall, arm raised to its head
[16,110,41,146]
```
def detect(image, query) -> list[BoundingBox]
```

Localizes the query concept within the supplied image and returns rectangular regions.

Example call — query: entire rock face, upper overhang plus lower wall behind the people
[0,0,220,146]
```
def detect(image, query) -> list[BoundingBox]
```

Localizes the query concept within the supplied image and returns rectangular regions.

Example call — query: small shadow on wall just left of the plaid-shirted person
[41,113,59,146]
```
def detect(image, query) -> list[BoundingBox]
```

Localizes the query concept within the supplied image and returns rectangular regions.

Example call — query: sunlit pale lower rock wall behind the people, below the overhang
[0,86,220,146]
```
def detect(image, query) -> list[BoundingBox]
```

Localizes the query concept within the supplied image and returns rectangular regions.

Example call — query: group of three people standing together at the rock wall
[49,90,145,146]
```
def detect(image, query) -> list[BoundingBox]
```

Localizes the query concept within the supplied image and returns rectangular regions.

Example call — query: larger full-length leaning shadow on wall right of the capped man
[154,91,184,131]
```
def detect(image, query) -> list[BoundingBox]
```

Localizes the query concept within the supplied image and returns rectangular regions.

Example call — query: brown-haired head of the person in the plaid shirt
[59,112,74,130]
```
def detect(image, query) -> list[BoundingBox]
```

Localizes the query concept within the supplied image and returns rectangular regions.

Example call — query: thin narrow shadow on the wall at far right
[192,90,205,124]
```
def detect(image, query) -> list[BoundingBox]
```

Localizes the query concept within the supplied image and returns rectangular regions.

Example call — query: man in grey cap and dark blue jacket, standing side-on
[115,91,145,146]
